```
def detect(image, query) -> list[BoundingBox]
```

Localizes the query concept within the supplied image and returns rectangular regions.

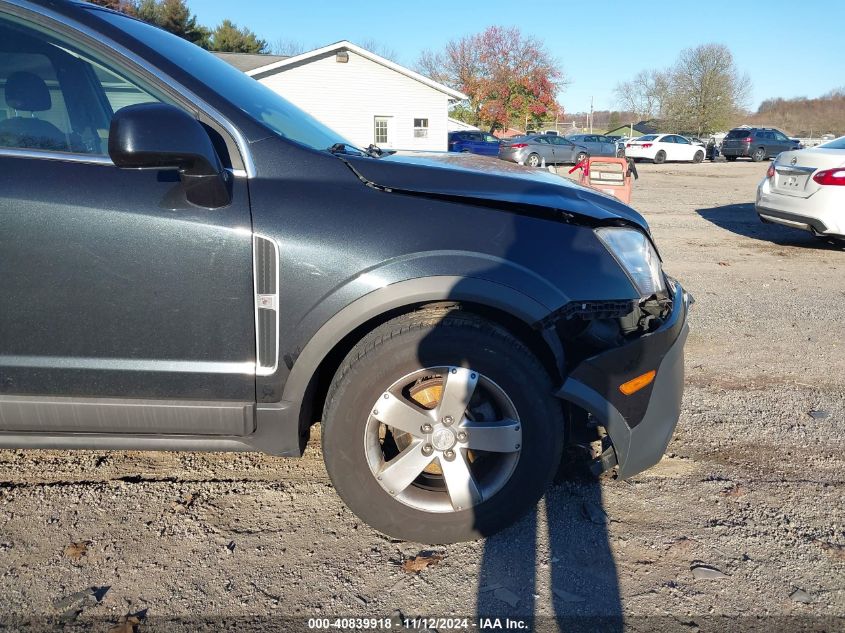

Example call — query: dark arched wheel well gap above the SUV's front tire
[299,301,561,445]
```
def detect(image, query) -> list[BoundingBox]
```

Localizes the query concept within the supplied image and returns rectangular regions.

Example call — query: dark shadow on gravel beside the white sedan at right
[696,202,843,251]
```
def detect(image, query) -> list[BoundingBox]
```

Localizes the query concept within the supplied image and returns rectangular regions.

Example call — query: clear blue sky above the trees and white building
[189,0,845,112]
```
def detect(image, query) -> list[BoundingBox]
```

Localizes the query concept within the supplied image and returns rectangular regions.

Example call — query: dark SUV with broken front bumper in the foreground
[0,0,689,542]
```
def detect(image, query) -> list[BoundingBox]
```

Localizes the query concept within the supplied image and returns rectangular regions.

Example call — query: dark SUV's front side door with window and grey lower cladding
[0,13,255,434]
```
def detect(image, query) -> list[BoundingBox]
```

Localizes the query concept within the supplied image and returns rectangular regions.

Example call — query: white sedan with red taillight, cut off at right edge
[755,136,845,240]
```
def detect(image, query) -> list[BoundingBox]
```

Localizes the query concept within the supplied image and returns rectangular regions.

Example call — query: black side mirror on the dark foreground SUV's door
[109,103,231,208]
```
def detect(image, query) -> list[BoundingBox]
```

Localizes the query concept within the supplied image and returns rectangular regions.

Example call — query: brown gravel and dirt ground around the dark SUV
[0,163,845,632]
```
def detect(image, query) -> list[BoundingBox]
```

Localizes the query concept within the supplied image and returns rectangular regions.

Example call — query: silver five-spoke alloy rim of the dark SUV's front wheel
[363,367,522,512]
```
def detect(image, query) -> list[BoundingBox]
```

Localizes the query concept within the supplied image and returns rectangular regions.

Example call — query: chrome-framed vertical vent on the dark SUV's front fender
[252,233,279,376]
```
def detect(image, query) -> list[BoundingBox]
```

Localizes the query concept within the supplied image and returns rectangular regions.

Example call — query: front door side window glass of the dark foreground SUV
[0,18,159,155]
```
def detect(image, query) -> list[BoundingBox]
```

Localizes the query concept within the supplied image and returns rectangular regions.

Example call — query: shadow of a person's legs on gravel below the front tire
[477,481,624,633]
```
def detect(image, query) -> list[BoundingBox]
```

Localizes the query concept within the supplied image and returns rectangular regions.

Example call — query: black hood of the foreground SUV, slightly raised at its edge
[343,152,648,231]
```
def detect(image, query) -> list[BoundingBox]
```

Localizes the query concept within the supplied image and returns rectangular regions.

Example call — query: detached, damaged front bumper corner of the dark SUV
[557,279,693,478]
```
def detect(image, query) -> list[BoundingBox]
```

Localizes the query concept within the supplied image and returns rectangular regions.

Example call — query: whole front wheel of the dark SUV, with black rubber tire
[323,309,564,543]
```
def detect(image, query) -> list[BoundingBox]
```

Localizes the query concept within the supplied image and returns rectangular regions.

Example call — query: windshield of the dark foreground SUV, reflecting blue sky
[89,7,347,150]
